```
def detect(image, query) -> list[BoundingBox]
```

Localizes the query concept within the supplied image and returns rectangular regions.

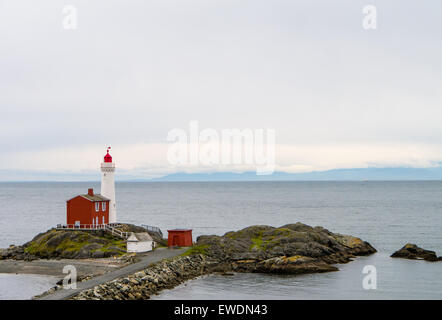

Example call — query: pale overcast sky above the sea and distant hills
[0,0,442,180]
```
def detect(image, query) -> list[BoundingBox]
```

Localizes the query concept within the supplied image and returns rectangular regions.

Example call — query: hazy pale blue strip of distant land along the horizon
[4,166,442,182]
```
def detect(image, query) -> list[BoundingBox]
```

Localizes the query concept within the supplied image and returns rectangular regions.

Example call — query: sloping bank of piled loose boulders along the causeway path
[71,254,217,300]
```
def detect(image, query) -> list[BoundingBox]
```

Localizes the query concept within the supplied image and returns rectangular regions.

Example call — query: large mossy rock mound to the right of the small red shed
[192,222,376,274]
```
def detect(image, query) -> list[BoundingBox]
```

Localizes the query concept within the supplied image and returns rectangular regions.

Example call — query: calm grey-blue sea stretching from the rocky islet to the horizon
[0,181,442,299]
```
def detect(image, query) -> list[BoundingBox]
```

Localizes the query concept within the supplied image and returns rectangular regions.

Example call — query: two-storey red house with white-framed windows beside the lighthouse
[66,189,110,228]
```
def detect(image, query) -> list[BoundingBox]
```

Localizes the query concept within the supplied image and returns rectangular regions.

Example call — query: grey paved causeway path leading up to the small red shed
[37,248,187,300]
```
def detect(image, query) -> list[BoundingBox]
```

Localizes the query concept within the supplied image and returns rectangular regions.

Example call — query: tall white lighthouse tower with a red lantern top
[101,147,117,223]
